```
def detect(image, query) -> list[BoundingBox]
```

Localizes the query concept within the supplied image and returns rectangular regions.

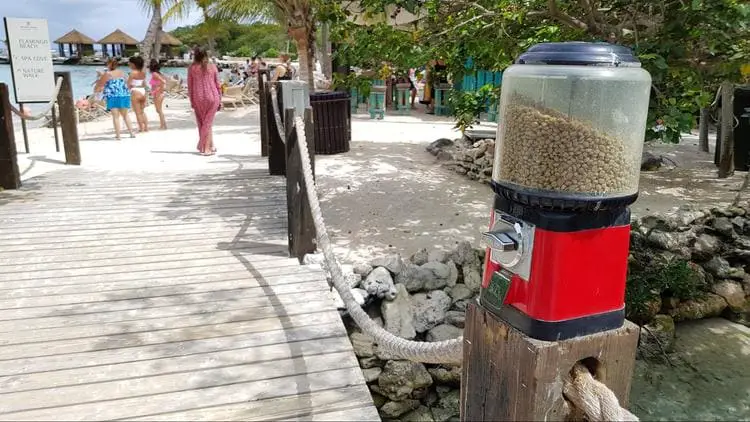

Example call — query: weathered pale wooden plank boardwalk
[0,161,379,421]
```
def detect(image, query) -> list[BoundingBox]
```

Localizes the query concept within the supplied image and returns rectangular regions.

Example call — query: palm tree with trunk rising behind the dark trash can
[215,0,315,91]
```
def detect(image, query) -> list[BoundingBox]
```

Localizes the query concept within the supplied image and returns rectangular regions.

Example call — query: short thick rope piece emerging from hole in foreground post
[563,363,638,421]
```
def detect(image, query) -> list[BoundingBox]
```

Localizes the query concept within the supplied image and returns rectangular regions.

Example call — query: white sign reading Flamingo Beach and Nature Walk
[5,18,55,103]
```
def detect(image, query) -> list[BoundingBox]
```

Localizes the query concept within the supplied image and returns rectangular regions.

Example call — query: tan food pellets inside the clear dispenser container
[499,100,638,196]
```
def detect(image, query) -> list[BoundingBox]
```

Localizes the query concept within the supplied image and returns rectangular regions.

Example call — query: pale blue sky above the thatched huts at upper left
[0,0,200,41]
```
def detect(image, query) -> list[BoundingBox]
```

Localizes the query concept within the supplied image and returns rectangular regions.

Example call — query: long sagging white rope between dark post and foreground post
[295,113,463,363]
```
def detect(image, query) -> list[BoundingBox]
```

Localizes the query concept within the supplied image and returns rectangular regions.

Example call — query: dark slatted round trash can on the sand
[310,91,352,154]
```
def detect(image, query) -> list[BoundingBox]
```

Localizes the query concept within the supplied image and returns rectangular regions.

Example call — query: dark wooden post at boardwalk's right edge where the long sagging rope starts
[284,108,315,262]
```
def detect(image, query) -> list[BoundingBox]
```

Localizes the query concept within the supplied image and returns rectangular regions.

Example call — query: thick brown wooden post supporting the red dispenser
[461,303,639,421]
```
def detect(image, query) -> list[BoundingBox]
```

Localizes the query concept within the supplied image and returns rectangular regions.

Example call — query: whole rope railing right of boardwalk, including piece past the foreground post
[282,104,638,421]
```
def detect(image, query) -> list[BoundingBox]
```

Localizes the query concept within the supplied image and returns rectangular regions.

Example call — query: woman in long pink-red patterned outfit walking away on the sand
[188,47,221,155]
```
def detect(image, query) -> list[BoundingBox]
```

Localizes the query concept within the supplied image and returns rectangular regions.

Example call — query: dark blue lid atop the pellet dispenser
[516,41,640,66]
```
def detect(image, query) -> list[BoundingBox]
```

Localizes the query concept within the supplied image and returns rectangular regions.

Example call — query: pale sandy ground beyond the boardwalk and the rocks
[10,99,744,262]
